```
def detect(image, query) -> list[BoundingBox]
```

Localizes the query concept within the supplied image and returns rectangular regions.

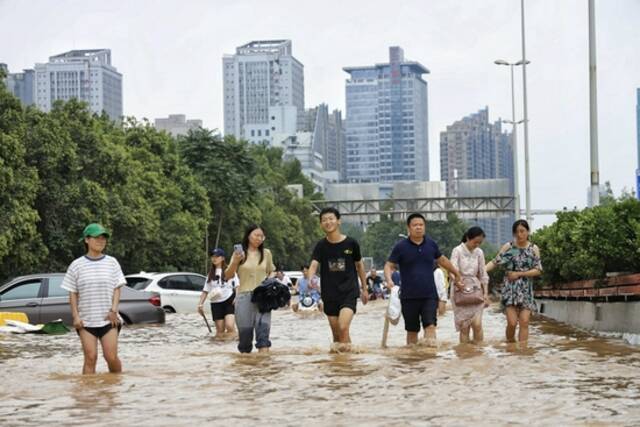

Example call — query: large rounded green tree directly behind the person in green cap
[19,100,209,272]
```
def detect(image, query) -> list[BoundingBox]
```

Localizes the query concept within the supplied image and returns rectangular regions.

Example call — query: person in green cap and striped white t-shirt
[62,223,127,374]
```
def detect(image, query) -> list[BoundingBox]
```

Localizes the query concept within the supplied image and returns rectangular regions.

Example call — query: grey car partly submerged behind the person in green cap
[0,273,165,326]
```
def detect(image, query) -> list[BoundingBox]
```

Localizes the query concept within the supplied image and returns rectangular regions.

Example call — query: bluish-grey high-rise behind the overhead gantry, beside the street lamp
[440,107,515,245]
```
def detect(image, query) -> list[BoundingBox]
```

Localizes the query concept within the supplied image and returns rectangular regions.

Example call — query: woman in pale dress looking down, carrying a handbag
[451,227,489,343]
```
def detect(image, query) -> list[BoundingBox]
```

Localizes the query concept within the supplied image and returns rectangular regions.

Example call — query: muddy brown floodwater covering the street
[0,301,640,426]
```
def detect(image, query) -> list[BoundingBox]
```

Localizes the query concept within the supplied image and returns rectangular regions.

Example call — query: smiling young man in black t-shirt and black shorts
[309,207,369,350]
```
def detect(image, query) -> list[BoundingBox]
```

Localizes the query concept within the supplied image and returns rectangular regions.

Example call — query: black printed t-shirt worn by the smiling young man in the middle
[312,237,362,301]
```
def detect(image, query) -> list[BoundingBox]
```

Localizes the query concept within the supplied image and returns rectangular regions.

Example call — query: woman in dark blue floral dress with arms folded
[486,219,542,342]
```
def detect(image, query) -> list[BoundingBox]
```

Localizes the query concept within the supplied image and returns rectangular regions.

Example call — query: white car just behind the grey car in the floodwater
[125,272,207,313]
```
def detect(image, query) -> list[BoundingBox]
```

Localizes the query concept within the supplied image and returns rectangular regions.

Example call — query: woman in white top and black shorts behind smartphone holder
[198,248,239,339]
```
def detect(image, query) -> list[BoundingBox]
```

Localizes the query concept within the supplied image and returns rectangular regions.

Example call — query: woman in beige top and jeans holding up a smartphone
[225,224,276,353]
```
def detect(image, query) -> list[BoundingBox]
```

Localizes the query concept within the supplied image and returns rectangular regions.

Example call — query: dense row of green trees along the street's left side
[0,79,320,279]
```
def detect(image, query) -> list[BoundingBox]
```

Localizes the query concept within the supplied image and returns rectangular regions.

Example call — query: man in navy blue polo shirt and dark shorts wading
[384,213,462,347]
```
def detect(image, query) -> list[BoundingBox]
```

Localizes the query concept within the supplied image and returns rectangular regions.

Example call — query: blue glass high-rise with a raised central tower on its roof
[343,47,429,182]
